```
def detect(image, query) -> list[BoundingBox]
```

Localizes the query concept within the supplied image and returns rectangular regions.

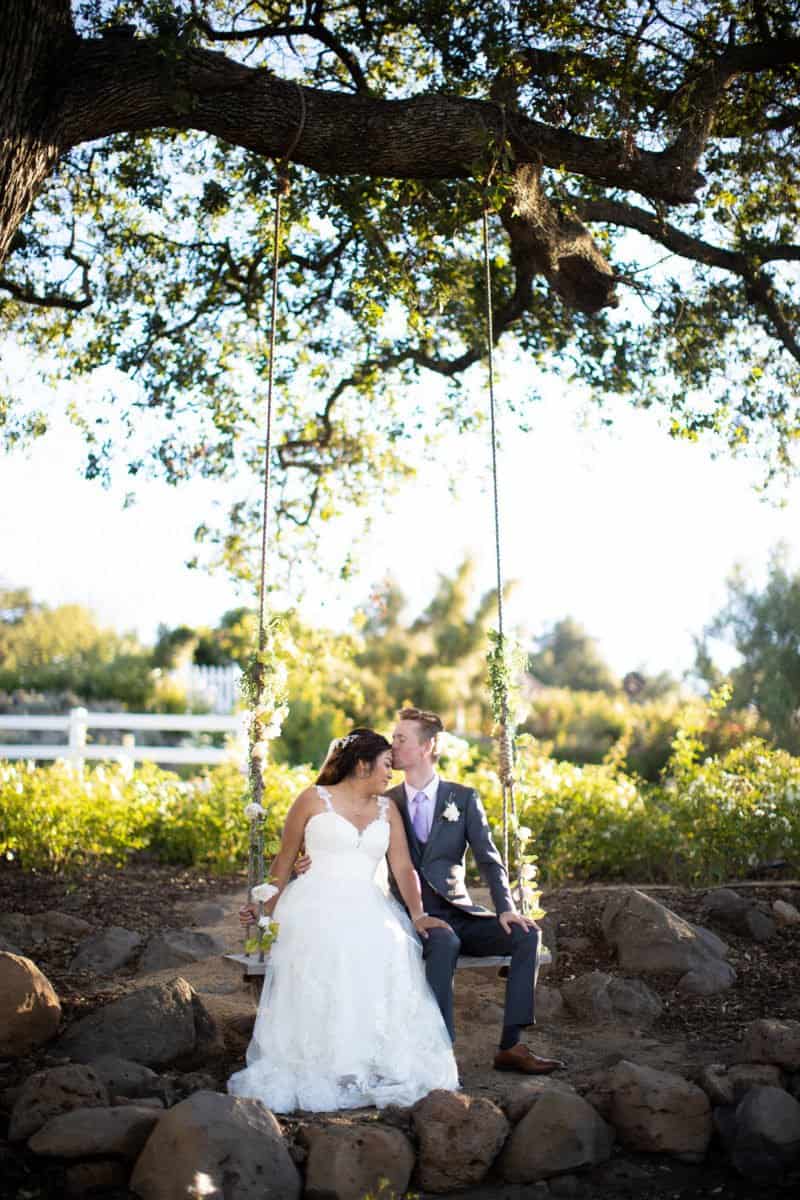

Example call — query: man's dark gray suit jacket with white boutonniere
[386,779,515,917]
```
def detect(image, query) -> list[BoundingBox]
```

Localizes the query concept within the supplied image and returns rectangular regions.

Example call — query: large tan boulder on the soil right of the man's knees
[602,888,728,976]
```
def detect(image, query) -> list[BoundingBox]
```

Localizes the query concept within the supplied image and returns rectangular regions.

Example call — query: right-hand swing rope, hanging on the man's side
[482,202,528,916]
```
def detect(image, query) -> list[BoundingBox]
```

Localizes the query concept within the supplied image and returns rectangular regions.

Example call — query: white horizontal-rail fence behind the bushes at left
[0,708,247,767]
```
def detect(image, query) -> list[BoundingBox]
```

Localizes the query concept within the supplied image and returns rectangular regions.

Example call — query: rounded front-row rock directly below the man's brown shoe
[500,1091,614,1183]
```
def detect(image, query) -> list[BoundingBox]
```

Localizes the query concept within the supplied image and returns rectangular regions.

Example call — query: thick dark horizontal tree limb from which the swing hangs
[59,38,703,204]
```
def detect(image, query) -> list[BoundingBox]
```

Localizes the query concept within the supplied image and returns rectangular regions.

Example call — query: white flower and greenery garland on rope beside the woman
[241,617,289,961]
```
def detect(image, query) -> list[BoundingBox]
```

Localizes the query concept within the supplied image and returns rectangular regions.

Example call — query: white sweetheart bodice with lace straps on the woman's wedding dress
[306,785,390,880]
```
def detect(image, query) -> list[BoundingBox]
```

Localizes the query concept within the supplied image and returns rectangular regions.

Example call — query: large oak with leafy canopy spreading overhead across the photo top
[0,0,800,570]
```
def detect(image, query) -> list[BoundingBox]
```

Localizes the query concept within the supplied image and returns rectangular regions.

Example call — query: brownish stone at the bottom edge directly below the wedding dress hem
[303,1124,415,1200]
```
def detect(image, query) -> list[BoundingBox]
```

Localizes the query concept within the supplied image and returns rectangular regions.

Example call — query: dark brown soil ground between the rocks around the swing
[0,859,800,1200]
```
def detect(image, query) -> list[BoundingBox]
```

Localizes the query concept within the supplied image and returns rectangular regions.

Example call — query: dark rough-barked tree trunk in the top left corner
[0,0,74,263]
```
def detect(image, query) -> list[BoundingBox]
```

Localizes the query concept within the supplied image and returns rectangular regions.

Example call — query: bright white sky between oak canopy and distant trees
[0,348,800,674]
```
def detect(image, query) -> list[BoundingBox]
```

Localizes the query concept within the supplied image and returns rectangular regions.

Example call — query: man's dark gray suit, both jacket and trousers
[386,780,541,1038]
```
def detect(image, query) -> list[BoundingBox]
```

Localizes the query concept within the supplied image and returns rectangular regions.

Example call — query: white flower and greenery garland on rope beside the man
[486,630,545,920]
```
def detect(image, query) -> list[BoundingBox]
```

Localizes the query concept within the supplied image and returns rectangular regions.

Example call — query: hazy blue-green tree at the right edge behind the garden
[697,547,800,754]
